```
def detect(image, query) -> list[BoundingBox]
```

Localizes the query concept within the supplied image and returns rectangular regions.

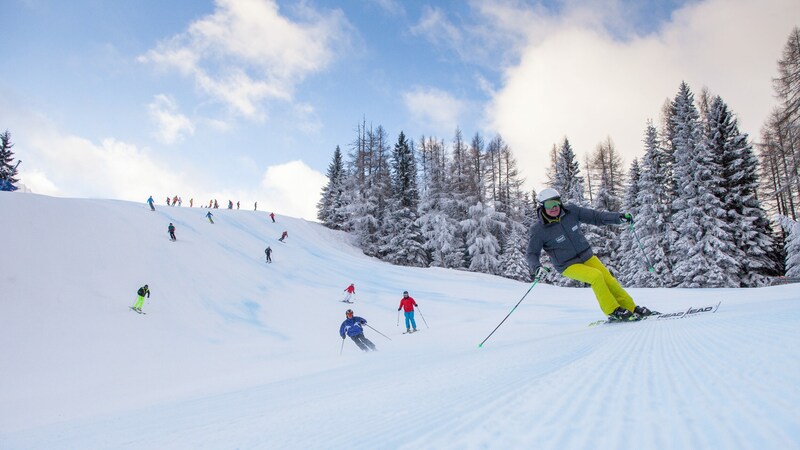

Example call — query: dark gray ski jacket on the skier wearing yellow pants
[525,205,622,273]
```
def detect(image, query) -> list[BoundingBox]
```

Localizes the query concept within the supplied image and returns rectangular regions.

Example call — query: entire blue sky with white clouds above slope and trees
[0,0,800,218]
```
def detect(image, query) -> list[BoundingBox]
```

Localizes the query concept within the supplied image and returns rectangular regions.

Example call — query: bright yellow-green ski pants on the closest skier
[562,256,636,315]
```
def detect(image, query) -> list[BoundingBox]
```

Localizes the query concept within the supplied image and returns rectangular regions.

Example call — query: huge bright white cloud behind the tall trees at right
[482,0,800,188]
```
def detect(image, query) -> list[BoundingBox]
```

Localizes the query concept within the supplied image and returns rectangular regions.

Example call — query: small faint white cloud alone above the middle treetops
[403,87,465,136]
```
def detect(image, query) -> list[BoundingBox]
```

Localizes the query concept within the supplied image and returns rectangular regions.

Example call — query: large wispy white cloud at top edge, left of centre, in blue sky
[139,0,348,120]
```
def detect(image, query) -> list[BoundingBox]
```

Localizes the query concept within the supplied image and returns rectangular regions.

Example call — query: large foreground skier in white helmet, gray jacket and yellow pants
[525,188,653,321]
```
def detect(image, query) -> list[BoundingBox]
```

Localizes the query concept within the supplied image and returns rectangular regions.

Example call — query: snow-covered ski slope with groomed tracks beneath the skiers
[0,193,800,449]
